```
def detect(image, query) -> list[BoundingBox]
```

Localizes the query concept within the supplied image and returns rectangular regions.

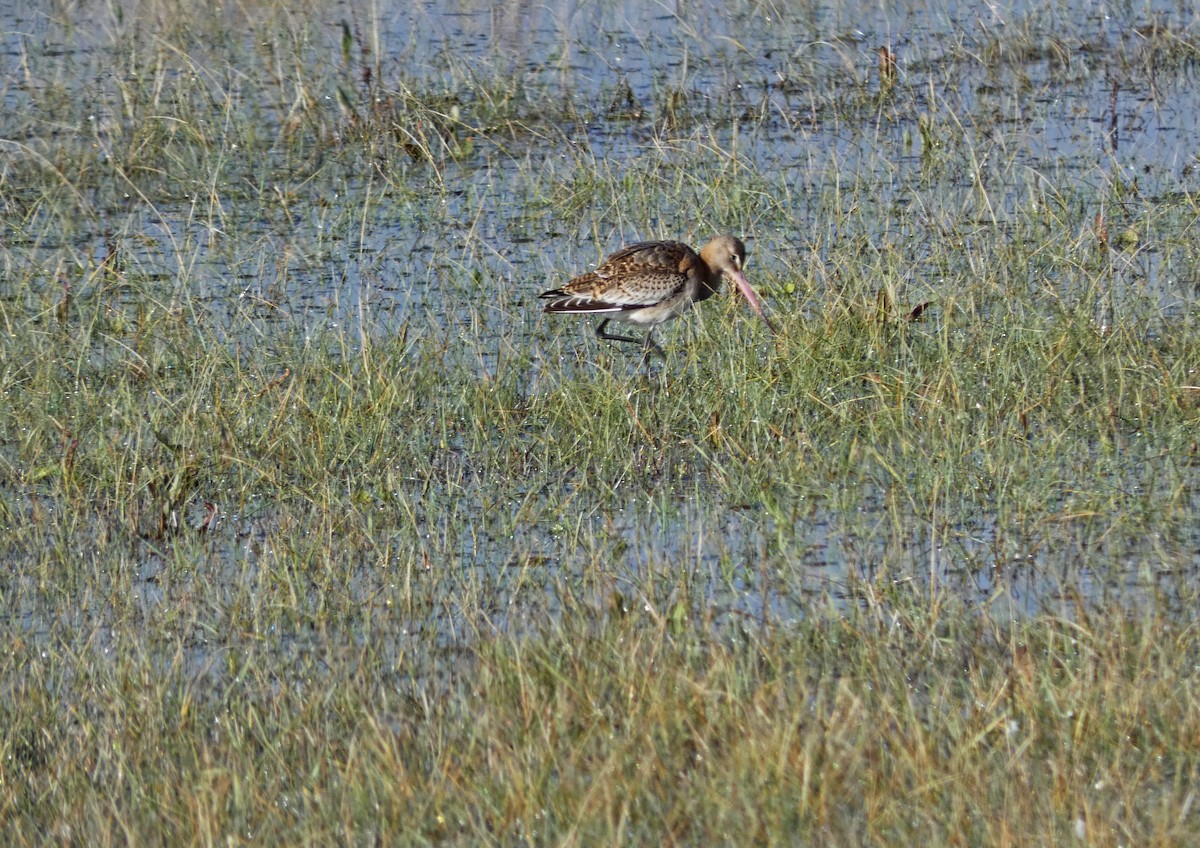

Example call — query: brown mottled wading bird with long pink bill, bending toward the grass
[539,235,774,359]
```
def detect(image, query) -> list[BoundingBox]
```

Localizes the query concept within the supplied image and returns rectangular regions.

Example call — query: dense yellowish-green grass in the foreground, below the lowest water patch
[5,591,1200,844]
